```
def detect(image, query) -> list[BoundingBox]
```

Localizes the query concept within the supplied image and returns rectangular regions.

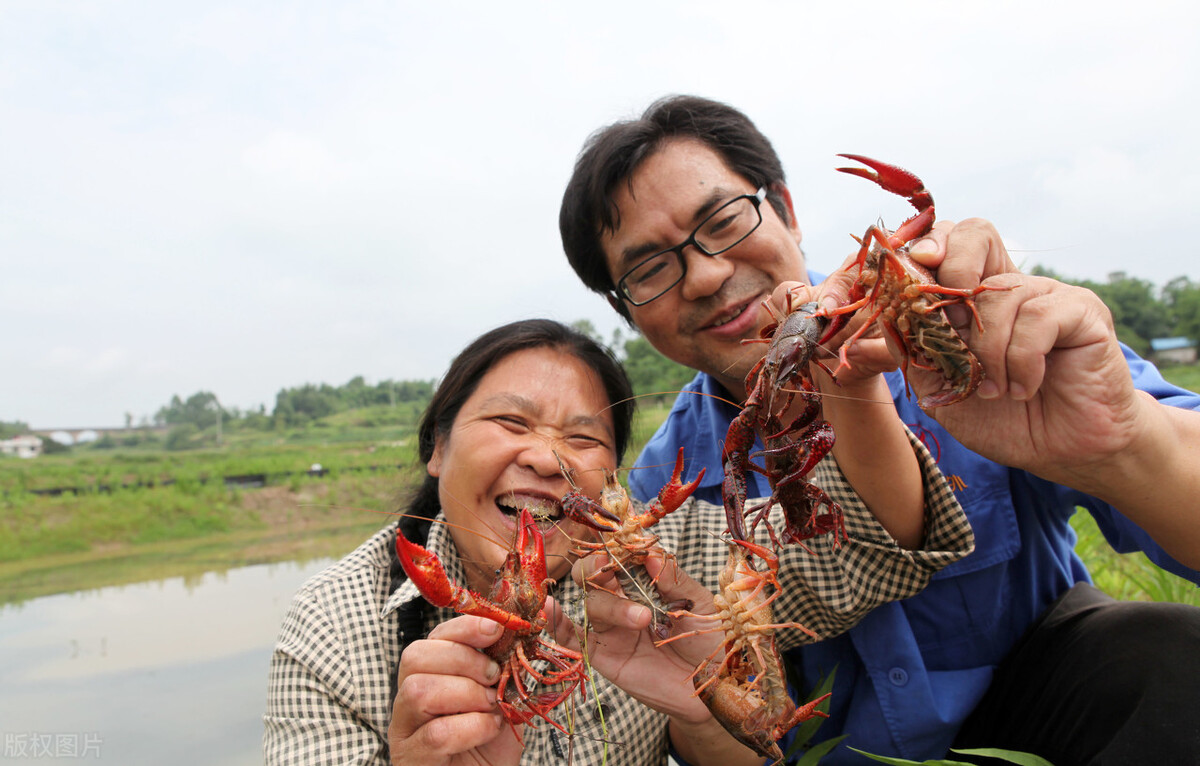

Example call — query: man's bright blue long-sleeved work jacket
[629,347,1200,764]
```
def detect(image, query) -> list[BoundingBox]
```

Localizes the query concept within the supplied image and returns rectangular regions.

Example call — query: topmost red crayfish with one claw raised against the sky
[822,154,1009,409]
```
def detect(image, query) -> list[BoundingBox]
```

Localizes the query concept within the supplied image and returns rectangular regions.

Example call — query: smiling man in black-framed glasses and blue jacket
[559,97,1200,766]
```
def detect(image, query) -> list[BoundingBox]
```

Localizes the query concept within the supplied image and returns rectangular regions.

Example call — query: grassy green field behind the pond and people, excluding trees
[0,365,1200,605]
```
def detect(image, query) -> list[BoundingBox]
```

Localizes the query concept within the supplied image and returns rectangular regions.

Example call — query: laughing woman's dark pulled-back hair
[400,319,635,545]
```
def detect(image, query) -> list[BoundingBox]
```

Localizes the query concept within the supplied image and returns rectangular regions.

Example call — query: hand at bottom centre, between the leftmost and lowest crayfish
[547,549,724,723]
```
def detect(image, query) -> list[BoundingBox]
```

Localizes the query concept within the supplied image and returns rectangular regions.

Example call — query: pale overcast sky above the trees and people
[0,0,1200,427]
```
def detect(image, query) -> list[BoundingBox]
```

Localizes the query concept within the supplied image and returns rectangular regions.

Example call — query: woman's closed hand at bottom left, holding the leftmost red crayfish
[388,616,522,766]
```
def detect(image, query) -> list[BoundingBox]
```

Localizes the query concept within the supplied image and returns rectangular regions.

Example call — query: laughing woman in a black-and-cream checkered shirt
[264,319,971,764]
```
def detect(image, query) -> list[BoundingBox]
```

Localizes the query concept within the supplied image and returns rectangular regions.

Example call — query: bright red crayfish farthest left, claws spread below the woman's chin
[396,508,587,738]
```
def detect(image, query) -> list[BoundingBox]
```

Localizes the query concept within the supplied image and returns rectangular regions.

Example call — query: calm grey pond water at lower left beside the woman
[0,559,331,766]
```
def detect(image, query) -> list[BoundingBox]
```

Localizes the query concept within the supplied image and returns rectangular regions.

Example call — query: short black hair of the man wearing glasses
[558,96,792,321]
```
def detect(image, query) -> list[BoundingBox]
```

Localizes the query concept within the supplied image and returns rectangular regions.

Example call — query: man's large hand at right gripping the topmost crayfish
[910,219,1140,487]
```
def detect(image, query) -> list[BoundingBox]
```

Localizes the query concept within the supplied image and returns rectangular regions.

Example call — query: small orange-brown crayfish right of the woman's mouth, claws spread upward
[562,447,704,639]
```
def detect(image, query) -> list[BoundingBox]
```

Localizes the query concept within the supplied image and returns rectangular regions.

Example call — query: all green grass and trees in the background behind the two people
[0,306,1200,604]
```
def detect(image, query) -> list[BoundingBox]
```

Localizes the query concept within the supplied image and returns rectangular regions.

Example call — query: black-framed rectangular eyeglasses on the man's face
[617,187,767,306]
